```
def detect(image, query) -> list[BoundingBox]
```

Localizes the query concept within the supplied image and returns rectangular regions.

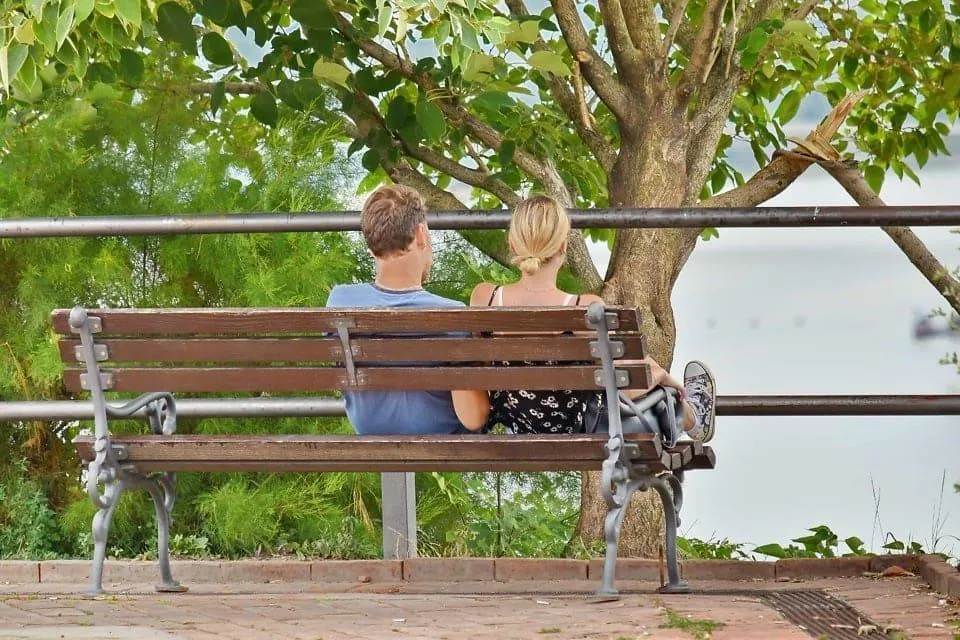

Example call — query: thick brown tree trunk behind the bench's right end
[577,114,697,558]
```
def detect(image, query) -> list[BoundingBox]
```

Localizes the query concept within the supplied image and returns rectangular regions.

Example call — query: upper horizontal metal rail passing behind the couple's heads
[0,205,960,238]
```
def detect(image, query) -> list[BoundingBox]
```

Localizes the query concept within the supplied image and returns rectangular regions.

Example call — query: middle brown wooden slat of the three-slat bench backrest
[59,335,646,364]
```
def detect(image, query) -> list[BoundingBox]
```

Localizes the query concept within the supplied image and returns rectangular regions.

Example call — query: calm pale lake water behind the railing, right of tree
[594,138,960,554]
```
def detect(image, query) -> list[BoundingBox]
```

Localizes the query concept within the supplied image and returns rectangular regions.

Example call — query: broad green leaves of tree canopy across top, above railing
[0,0,960,218]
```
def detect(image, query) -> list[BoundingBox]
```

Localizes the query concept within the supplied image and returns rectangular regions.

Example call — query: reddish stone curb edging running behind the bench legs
[0,555,960,598]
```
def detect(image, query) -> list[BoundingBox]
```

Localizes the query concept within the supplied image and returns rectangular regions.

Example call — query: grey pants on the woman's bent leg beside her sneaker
[584,387,683,447]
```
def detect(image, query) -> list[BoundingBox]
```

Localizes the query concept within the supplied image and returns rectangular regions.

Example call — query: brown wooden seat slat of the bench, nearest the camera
[74,434,670,471]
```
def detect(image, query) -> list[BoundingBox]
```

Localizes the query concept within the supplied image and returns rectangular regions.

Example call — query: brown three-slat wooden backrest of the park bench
[53,307,650,393]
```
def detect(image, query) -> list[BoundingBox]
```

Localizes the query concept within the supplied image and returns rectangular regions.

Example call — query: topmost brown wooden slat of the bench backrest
[52,307,640,336]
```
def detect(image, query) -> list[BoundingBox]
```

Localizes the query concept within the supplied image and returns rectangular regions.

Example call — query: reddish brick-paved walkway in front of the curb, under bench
[0,577,960,640]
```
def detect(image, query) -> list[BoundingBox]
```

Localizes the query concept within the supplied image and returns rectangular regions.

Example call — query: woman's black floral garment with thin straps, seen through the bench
[487,286,599,434]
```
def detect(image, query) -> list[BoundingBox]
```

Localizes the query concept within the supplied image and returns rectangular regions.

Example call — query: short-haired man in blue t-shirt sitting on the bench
[327,185,488,435]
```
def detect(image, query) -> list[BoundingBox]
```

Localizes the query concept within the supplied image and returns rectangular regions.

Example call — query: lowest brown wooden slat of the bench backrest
[64,364,650,393]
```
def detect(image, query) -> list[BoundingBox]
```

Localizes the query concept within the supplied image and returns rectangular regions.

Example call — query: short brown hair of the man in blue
[360,184,427,258]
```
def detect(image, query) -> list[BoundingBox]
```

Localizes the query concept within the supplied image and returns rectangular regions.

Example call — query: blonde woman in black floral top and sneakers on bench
[454,195,716,441]
